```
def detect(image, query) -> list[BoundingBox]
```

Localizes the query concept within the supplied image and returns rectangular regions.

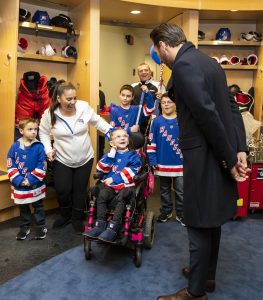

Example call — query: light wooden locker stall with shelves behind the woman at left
[0,0,100,221]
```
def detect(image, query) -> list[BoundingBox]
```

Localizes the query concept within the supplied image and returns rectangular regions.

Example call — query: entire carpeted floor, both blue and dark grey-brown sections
[0,176,263,300]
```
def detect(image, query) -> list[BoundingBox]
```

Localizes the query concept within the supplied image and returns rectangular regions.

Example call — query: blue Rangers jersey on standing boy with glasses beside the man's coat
[147,115,183,177]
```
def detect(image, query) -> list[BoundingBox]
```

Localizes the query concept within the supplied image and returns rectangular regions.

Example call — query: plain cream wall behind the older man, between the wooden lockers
[100,25,158,105]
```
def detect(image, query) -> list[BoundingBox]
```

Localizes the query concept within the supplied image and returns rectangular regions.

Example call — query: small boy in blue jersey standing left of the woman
[7,119,47,240]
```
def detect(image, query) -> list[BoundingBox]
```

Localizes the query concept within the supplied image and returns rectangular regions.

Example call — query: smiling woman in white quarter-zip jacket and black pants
[39,81,111,232]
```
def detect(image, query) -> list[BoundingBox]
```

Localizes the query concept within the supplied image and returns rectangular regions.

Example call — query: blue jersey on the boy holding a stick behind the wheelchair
[110,92,155,134]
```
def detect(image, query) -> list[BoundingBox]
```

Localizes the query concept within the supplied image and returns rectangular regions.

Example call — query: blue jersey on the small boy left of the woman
[7,138,46,204]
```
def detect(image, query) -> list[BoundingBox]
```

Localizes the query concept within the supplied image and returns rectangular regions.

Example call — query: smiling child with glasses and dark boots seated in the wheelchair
[83,128,141,242]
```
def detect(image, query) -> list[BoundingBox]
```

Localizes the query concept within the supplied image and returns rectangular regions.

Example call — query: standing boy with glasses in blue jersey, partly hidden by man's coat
[147,93,183,225]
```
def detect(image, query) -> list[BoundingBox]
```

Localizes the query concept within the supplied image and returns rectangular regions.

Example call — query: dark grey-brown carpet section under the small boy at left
[0,210,82,284]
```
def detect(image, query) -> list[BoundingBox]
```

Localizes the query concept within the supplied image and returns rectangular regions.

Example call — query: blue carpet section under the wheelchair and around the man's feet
[0,213,263,300]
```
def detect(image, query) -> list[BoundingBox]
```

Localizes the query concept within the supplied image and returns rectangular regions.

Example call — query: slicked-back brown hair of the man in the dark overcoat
[150,23,187,48]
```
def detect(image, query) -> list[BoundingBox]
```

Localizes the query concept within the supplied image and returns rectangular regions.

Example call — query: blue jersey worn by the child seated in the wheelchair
[96,149,141,190]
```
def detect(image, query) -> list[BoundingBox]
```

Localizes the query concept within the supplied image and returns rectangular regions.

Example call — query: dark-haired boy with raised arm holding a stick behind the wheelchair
[110,84,154,134]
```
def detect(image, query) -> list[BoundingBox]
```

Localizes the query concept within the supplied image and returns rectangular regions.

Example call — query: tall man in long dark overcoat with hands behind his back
[150,24,248,300]
